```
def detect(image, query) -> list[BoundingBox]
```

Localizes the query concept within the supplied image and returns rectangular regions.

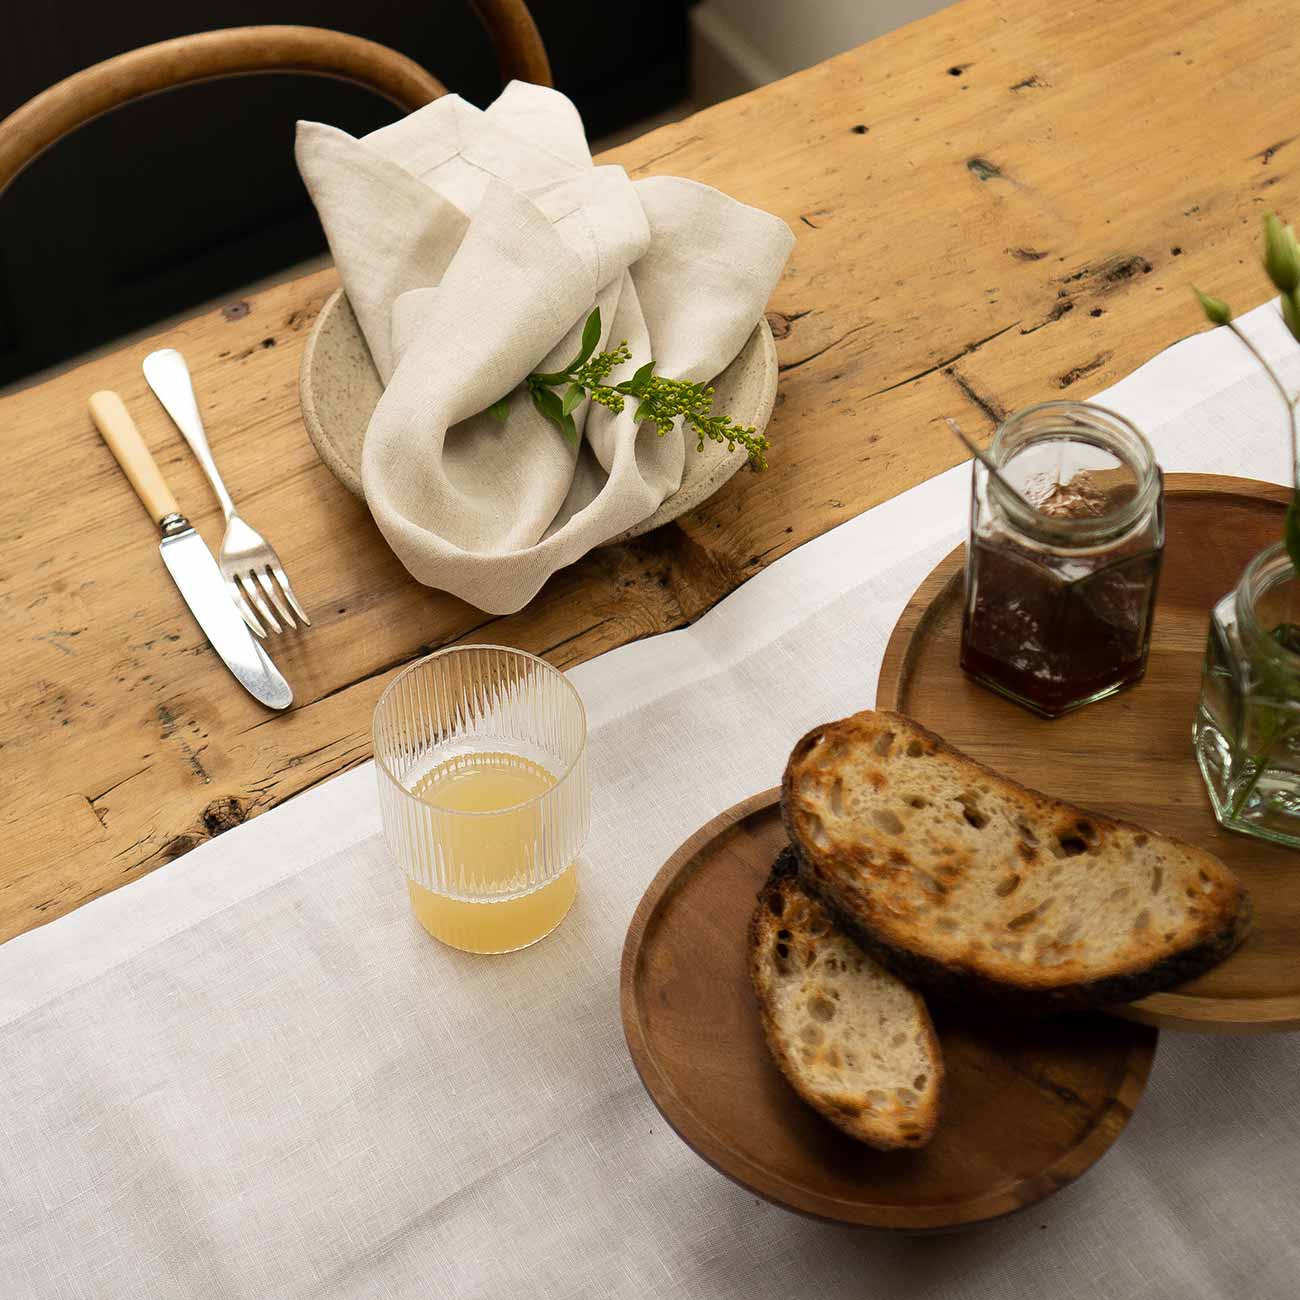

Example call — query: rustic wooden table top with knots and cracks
[0,0,1300,940]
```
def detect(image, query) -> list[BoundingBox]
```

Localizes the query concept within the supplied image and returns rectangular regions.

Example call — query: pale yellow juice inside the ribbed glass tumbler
[407,751,577,953]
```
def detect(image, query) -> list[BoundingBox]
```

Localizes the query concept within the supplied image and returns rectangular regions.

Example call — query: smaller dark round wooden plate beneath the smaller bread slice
[620,790,1157,1231]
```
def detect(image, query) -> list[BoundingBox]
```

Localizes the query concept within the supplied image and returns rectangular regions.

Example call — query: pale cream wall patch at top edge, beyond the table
[692,0,950,86]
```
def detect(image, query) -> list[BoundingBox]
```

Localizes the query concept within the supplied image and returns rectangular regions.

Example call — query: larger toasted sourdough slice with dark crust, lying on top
[781,712,1249,1010]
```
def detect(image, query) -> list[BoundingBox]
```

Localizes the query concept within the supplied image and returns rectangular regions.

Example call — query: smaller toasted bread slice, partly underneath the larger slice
[749,849,944,1151]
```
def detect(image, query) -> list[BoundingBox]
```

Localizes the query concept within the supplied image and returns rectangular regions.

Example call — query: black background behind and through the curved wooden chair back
[0,0,692,384]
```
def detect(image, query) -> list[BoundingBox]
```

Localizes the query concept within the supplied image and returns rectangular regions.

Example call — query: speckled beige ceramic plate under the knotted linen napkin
[298,290,776,542]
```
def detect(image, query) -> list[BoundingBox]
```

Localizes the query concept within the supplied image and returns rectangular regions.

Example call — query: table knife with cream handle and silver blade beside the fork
[90,390,294,709]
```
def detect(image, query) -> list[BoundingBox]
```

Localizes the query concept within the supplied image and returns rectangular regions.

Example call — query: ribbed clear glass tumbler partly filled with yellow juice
[373,646,592,953]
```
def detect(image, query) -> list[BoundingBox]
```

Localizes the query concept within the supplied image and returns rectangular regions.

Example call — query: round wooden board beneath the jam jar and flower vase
[876,475,1300,1034]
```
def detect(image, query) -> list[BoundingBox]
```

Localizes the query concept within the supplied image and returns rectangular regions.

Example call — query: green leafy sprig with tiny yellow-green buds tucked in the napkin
[489,307,771,469]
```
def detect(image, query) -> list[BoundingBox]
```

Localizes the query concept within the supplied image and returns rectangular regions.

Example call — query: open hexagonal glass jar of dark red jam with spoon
[962,402,1165,718]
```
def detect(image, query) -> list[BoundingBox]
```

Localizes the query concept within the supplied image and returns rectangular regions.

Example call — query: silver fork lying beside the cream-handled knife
[143,347,312,637]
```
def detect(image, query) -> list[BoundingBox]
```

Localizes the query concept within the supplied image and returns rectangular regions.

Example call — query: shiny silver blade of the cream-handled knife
[159,515,294,709]
